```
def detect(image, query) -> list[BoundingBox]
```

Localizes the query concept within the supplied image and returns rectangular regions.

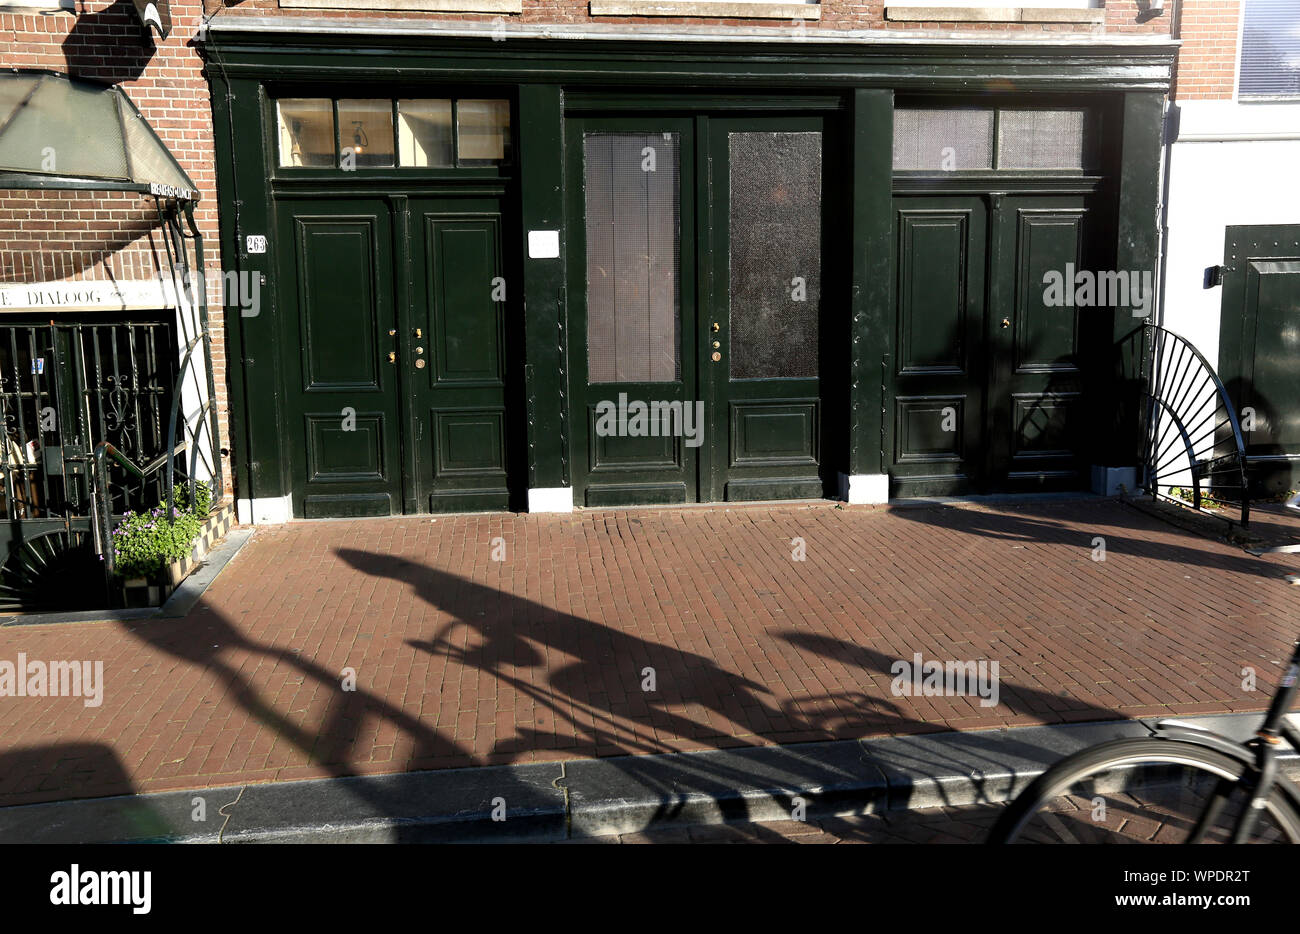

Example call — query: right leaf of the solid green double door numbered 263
[402,198,523,511]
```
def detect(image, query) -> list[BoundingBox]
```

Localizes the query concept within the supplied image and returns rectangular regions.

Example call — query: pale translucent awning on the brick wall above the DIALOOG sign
[0,69,199,200]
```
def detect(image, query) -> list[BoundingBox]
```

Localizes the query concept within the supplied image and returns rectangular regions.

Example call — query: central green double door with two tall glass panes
[566,116,846,506]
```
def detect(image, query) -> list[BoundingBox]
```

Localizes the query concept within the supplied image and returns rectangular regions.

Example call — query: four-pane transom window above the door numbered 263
[276,98,511,170]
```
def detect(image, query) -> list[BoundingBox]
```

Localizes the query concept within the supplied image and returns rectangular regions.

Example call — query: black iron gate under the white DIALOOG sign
[0,312,183,611]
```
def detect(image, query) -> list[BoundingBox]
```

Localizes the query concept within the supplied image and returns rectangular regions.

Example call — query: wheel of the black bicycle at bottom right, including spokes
[989,739,1300,843]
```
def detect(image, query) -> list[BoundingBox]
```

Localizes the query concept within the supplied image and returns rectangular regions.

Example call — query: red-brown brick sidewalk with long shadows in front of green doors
[0,500,1300,804]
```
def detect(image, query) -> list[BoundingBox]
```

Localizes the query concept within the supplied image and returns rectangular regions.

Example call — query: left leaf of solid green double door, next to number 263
[270,196,402,518]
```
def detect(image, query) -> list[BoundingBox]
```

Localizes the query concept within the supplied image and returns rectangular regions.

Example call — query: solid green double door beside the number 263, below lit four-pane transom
[273,193,521,518]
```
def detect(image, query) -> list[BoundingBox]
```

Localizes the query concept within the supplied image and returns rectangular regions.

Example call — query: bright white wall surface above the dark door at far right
[1162,100,1300,368]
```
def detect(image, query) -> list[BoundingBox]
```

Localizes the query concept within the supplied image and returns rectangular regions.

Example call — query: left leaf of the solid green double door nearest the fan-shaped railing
[892,196,988,497]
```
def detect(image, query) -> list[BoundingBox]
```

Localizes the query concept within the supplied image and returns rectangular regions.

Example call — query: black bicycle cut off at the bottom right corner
[988,641,1300,843]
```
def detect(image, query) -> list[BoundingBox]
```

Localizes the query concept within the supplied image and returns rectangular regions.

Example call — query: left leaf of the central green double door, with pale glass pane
[567,118,703,506]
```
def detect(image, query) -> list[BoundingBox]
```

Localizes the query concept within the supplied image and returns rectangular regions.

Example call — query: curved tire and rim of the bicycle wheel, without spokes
[988,738,1300,843]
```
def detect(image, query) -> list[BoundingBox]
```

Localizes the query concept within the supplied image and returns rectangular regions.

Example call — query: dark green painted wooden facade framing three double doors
[203,23,1173,516]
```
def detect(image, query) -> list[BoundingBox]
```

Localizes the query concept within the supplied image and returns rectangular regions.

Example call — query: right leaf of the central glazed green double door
[697,117,826,501]
